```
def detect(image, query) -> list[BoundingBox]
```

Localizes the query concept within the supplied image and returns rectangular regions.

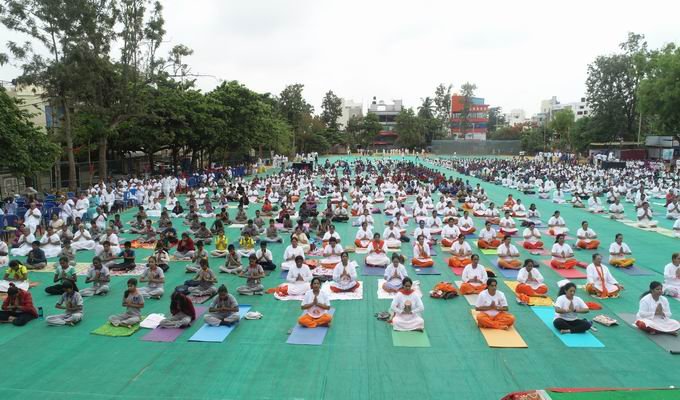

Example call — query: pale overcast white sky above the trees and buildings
[0,0,680,116]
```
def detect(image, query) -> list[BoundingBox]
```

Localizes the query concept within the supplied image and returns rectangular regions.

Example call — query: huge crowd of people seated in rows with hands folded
[0,156,680,340]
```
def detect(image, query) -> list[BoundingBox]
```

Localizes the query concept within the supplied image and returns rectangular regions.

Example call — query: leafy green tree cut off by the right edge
[639,44,680,135]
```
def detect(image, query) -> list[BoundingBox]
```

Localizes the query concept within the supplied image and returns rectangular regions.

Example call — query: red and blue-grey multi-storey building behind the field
[451,94,489,140]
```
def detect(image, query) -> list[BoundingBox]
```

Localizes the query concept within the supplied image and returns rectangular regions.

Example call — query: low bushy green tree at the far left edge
[0,87,60,178]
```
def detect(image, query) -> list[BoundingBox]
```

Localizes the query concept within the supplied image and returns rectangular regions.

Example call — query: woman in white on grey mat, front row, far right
[635,281,680,335]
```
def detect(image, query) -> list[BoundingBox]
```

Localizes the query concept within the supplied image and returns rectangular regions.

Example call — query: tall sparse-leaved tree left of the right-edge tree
[586,33,649,139]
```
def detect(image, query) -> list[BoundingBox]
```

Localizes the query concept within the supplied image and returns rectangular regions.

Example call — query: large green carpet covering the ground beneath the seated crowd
[0,156,679,400]
